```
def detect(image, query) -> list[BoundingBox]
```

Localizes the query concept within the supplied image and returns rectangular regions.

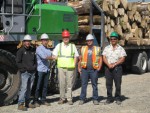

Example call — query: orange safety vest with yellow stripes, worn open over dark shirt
[81,46,100,69]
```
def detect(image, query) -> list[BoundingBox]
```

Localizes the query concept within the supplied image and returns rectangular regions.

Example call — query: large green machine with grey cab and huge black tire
[0,0,78,105]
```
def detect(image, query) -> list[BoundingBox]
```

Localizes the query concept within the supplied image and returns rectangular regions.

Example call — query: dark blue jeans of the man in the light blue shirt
[35,71,50,101]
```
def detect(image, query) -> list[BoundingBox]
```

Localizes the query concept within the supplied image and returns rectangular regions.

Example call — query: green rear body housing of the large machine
[26,4,78,40]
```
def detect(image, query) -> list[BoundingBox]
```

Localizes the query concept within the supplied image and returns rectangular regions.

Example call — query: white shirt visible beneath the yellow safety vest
[53,42,79,57]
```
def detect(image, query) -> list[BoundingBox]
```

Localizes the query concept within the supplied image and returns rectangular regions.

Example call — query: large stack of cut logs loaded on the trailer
[68,0,150,46]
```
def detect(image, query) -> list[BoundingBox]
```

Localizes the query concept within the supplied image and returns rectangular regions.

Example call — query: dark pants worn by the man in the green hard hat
[105,65,122,99]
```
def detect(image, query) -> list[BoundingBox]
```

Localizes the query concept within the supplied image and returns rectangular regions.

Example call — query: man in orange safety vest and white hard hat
[78,34,102,105]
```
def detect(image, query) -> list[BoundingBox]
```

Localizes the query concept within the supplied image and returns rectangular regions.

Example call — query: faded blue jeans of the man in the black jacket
[18,71,35,104]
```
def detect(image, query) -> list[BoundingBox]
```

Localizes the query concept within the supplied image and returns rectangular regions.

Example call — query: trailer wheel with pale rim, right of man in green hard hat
[131,52,148,74]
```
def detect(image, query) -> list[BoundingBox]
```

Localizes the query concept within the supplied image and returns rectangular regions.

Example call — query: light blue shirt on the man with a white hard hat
[36,45,52,72]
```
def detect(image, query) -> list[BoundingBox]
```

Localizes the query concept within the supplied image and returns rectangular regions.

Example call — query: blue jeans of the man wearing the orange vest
[80,69,98,101]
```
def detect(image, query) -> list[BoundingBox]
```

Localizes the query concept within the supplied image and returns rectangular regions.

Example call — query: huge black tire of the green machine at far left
[0,49,21,105]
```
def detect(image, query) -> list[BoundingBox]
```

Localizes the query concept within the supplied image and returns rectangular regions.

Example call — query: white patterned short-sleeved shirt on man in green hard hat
[102,44,127,64]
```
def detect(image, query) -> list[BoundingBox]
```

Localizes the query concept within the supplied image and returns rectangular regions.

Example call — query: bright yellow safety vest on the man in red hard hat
[57,43,75,68]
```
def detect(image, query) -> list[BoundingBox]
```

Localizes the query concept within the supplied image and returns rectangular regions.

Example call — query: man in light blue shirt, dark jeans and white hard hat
[35,33,52,107]
